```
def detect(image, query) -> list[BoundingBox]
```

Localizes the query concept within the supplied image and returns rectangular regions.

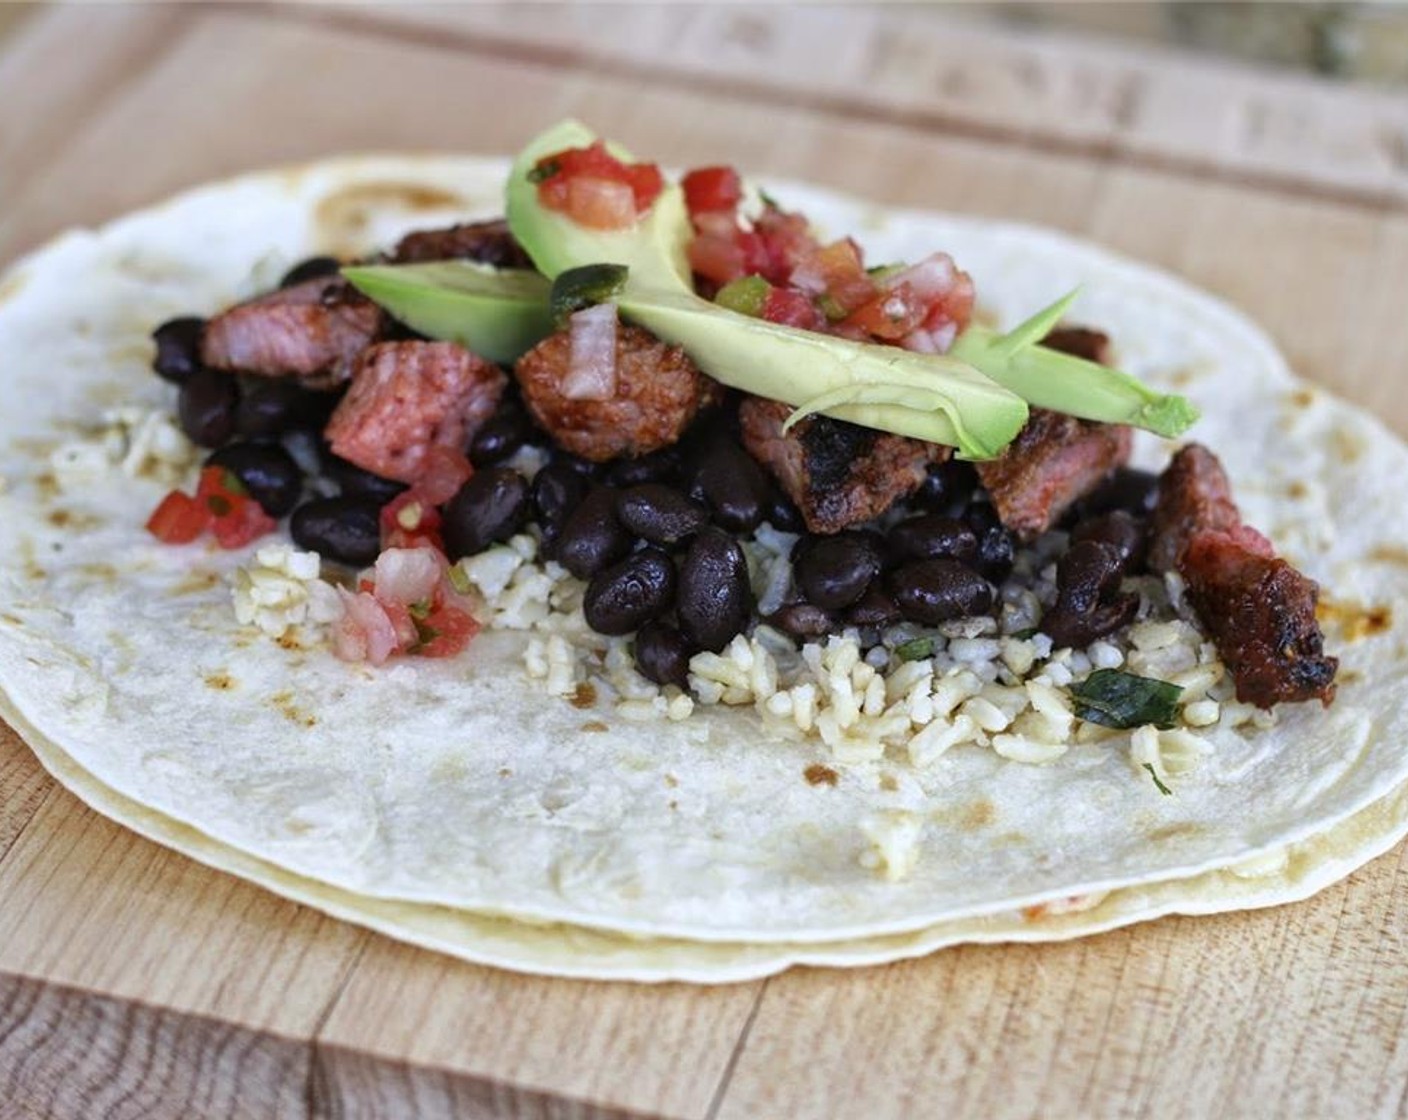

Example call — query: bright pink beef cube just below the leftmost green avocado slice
[325,342,508,482]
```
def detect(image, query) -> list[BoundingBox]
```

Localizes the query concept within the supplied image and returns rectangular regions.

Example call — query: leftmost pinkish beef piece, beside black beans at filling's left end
[200,276,384,389]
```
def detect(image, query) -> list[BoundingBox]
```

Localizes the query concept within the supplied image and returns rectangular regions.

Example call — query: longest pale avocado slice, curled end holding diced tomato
[505,121,1028,459]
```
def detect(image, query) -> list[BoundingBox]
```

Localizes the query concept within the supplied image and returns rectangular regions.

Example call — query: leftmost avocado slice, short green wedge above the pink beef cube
[342,261,553,365]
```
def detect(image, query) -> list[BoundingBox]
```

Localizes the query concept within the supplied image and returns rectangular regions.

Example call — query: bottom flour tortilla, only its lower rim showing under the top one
[0,687,1408,983]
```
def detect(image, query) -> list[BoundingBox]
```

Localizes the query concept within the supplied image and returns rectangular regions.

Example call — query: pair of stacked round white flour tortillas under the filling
[0,158,1408,982]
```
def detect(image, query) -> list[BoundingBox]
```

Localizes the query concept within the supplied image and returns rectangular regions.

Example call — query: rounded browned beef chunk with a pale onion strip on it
[514,327,721,462]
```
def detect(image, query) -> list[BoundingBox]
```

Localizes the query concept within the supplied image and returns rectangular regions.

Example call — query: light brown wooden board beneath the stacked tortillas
[0,4,1408,1120]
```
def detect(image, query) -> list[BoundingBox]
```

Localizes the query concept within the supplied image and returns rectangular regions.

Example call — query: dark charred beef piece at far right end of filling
[1178,533,1339,707]
